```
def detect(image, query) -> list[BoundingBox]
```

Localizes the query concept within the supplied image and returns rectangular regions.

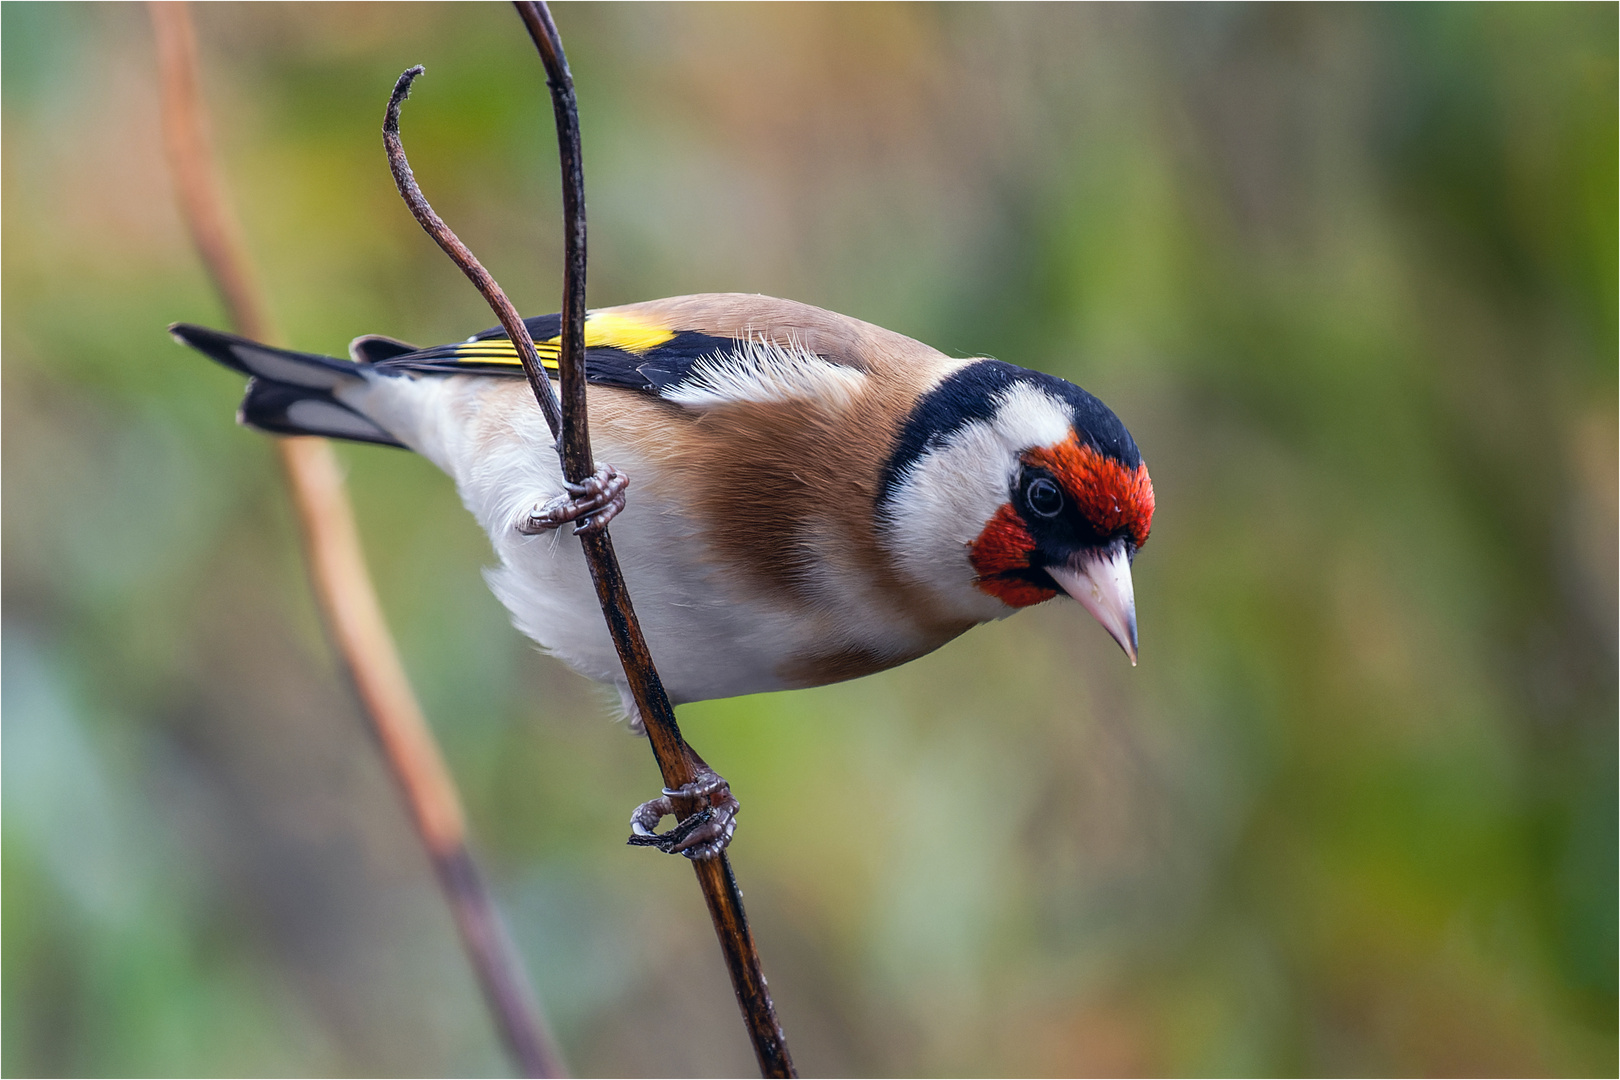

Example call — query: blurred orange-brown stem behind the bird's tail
[149,3,565,1077]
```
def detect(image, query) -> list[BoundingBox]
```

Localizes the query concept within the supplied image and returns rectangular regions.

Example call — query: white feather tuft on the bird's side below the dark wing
[661,338,867,408]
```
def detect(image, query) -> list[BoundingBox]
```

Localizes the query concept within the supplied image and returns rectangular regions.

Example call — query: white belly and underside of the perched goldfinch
[343,377,966,703]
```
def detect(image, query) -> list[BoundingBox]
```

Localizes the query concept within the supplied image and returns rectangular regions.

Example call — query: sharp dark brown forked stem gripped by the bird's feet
[382,3,797,1077]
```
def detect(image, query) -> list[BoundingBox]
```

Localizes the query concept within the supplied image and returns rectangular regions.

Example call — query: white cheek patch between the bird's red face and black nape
[885,384,1074,620]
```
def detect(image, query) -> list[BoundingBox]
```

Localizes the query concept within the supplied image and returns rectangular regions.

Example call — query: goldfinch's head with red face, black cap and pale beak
[878,359,1153,664]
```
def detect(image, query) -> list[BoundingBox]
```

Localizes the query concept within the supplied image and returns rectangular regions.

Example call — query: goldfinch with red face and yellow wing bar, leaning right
[170,293,1153,857]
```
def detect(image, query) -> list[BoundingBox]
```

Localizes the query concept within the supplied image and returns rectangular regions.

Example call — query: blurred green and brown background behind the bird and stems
[0,3,1617,1075]
